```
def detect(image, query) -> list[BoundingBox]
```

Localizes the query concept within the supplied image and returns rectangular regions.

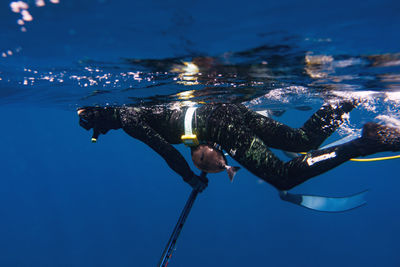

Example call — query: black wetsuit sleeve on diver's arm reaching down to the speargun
[122,118,193,181]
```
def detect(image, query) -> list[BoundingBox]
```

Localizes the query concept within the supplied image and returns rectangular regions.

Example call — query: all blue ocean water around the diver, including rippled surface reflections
[0,0,400,267]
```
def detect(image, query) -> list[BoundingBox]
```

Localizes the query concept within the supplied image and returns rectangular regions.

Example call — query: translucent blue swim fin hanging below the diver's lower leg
[279,190,368,212]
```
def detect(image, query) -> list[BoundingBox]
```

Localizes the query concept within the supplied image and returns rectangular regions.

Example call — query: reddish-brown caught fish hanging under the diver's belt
[191,145,240,182]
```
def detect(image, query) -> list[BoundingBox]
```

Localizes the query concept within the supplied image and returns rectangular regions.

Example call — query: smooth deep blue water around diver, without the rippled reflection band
[0,0,400,266]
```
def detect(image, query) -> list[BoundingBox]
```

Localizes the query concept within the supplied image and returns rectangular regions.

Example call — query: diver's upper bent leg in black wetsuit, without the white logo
[239,101,356,152]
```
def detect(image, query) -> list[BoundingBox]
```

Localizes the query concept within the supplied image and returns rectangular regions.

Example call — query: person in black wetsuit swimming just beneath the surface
[78,102,400,191]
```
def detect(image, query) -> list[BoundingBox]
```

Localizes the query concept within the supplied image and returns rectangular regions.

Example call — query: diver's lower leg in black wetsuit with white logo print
[208,106,400,190]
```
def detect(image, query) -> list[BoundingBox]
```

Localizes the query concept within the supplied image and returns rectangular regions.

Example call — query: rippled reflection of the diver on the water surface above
[76,45,400,109]
